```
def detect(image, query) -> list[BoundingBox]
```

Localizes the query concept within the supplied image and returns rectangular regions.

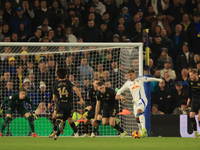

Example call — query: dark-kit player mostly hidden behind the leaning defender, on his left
[83,79,101,137]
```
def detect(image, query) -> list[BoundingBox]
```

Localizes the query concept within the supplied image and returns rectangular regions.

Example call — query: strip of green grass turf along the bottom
[0,137,200,150]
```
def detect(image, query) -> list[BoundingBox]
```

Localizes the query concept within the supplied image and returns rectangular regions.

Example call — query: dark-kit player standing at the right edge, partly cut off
[187,69,200,139]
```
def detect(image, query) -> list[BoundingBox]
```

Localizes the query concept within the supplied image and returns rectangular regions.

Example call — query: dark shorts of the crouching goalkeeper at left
[7,106,29,116]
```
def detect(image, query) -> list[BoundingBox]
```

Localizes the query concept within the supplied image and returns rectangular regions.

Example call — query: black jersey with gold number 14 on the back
[53,79,74,104]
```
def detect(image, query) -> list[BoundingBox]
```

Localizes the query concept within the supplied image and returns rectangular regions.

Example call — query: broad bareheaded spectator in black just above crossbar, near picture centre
[83,20,103,42]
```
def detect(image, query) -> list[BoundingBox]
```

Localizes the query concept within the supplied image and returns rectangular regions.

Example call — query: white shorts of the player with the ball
[133,99,148,117]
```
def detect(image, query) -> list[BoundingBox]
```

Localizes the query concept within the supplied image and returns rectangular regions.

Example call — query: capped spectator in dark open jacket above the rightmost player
[177,42,195,71]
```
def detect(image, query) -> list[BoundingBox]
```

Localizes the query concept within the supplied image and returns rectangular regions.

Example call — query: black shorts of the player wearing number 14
[56,103,74,121]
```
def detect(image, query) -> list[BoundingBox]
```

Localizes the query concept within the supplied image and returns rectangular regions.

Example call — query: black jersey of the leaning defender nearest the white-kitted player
[96,87,118,108]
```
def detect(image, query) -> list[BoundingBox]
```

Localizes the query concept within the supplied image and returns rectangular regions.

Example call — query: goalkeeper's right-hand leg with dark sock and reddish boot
[23,111,39,137]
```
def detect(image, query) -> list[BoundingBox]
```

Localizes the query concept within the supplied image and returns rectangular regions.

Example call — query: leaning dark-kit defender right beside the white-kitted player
[93,81,127,138]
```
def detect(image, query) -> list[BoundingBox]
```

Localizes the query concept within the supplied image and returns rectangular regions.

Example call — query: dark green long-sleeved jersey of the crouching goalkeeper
[2,94,35,110]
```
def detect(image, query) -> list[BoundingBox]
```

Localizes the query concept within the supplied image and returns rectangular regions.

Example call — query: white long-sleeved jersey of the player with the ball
[117,77,162,102]
